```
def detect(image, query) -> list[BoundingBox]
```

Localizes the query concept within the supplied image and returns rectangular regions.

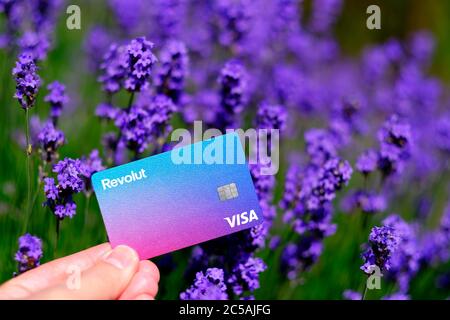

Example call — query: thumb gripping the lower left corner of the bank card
[30,246,139,300]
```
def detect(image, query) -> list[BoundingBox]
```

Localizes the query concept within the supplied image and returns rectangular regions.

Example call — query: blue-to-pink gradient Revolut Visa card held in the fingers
[92,133,263,259]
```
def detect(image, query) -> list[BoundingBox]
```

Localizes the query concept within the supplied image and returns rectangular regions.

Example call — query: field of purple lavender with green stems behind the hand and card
[0,0,450,300]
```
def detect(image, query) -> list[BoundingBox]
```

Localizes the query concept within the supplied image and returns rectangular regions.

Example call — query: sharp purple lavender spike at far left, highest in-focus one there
[12,54,41,109]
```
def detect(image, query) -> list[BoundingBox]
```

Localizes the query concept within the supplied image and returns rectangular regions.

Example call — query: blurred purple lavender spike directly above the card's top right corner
[215,61,247,130]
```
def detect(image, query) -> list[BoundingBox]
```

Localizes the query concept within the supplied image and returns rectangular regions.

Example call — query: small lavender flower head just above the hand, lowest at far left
[15,233,43,274]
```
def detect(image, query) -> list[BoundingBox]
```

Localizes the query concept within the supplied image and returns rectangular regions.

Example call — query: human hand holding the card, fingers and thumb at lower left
[0,243,159,300]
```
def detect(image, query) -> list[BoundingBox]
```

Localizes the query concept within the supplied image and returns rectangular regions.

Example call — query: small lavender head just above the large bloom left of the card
[38,121,65,163]
